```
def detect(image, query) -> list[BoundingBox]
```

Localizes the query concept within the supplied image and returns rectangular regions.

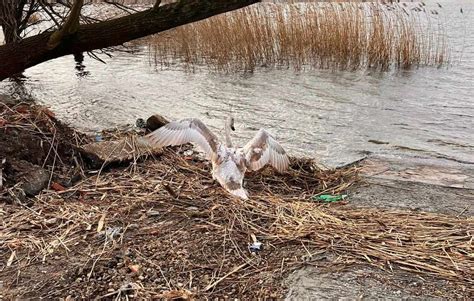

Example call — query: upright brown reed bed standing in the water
[148,1,449,72]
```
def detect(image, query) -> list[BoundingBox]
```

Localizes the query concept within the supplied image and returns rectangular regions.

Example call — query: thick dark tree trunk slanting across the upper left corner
[0,0,259,81]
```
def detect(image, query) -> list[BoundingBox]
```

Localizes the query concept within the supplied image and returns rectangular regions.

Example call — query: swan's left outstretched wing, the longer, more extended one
[145,118,219,158]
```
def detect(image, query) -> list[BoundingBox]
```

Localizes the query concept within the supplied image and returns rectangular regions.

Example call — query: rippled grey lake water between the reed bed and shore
[0,0,474,166]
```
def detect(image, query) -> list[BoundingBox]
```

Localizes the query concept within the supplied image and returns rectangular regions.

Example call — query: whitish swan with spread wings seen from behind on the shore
[144,117,289,199]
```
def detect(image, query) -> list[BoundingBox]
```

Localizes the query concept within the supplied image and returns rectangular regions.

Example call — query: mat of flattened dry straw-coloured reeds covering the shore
[0,141,474,298]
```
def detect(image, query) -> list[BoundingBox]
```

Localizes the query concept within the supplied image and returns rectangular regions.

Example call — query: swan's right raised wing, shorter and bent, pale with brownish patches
[244,129,290,172]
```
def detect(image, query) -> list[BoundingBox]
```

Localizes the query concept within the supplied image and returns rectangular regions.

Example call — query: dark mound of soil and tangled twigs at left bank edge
[0,99,87,203]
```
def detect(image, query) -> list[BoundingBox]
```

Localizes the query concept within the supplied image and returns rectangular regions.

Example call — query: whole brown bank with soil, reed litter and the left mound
[0,104,474,299]
